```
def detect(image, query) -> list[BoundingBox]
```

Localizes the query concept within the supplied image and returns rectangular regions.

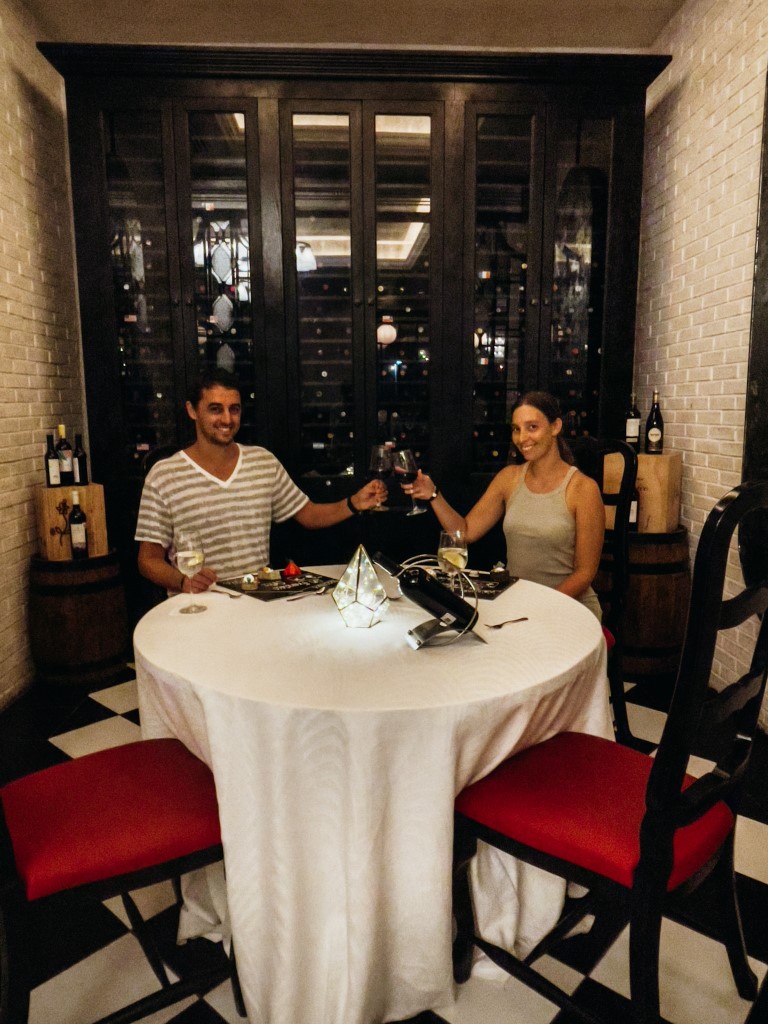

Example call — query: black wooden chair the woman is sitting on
[568,437,647,749]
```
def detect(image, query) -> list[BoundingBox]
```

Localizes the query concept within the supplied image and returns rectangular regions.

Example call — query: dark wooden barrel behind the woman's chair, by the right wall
[623,527,690,681]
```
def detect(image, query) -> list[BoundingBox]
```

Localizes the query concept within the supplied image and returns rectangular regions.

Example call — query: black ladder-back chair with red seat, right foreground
[454,481,768,1024]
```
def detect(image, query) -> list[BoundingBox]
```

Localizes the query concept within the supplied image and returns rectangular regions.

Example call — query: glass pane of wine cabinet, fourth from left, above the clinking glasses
[375,114,432,464]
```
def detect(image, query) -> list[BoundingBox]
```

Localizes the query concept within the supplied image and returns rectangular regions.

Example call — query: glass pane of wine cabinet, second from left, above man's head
[182,110,255,444]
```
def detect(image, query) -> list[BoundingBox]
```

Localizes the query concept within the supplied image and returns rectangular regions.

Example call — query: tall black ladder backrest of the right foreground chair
[640,480,768,884]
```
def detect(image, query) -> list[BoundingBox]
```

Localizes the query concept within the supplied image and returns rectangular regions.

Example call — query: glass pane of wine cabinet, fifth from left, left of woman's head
[465,112,538,474]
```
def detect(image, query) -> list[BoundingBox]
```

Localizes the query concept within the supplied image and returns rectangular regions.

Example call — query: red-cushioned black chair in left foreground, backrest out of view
[0,739,245,1024]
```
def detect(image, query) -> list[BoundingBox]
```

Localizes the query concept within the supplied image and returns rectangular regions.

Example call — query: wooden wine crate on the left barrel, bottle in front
[35,483,110,562]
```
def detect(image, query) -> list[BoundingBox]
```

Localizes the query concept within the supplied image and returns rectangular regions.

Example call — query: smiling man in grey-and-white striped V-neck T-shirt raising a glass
[136,370,386,593]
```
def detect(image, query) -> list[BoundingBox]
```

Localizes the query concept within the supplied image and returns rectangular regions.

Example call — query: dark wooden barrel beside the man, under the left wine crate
[29,552,131,686]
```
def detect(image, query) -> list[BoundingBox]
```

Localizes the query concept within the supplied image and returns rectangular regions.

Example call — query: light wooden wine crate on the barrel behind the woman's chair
[604,452,683,534]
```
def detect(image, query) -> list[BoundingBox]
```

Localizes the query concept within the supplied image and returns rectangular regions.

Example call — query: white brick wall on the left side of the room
[0,0,84,708]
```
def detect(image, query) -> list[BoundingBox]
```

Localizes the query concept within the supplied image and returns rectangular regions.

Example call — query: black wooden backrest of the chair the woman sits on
[568,437,637,636]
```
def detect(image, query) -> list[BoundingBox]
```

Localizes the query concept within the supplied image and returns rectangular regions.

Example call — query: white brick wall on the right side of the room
[635,0,768,692]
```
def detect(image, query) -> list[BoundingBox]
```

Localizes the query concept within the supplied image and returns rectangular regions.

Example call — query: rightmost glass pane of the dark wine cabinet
[547,116,612,438]
